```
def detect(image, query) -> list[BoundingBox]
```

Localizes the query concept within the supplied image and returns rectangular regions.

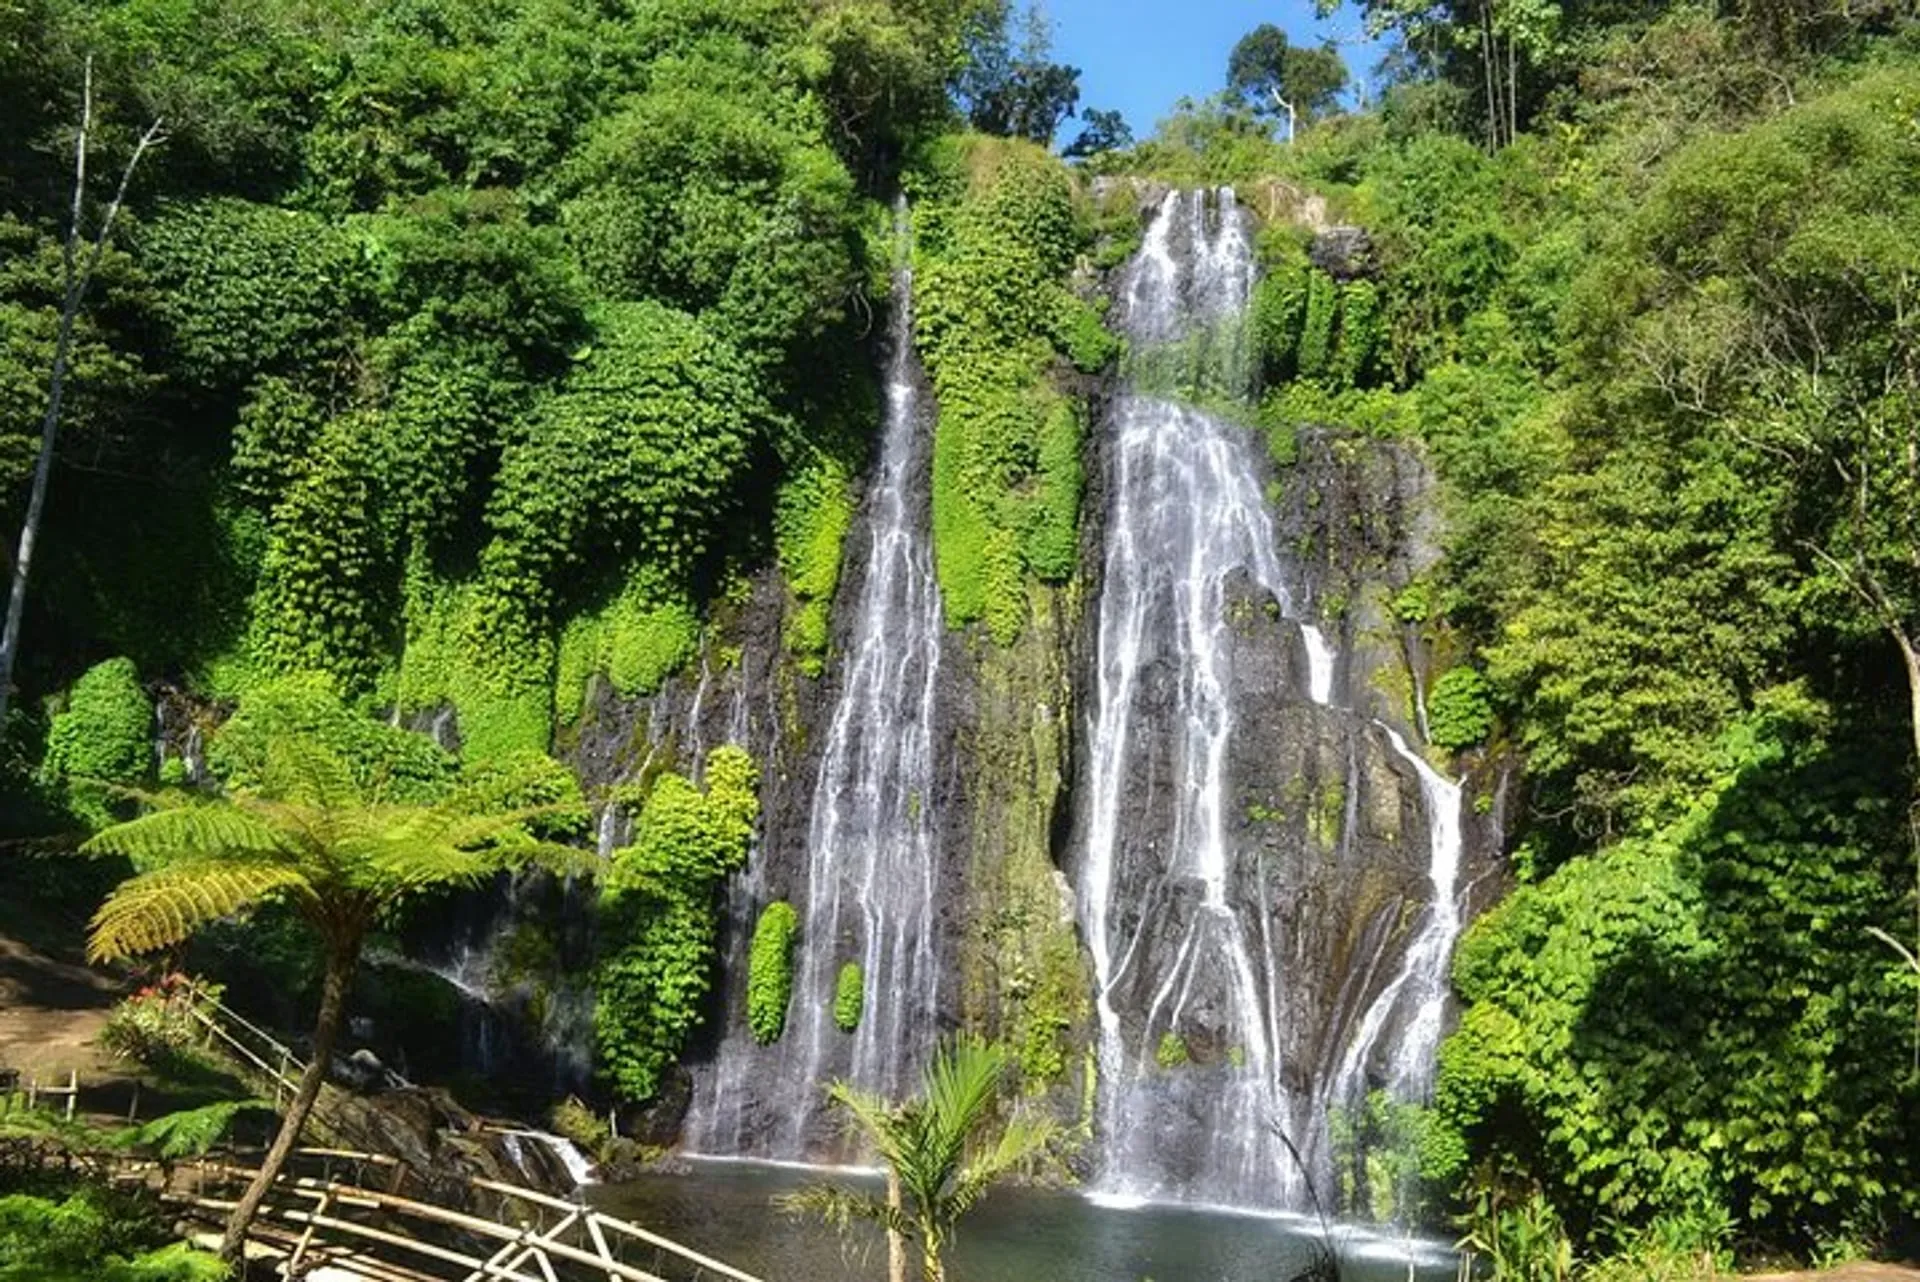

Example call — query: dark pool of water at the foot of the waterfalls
[591,1161,1455,1282]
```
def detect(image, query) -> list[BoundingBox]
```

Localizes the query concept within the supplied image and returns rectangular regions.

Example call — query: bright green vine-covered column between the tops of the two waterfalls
[914,138,1114,645]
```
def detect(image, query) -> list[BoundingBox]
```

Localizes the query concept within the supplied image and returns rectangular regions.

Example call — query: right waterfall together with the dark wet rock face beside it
[1068,185,1497,1205]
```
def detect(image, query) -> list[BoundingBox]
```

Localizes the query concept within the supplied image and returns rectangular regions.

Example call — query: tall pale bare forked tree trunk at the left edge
[0,58,159,735]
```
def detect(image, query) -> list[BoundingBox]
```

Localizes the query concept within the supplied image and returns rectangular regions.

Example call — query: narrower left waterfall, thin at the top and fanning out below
[687,205,945,1159]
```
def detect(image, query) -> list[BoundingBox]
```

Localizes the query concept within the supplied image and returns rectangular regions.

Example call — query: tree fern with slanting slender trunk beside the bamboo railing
[81,685,588,1259]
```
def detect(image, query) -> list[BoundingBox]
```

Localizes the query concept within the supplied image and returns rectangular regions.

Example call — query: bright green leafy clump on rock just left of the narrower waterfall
[593,747,760,1100]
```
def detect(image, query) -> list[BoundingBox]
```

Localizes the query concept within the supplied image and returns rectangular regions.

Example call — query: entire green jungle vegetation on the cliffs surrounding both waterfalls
[0,0,1920,1276]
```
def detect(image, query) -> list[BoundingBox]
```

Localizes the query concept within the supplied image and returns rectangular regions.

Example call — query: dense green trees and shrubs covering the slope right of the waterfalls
[1091,4,1920,1276]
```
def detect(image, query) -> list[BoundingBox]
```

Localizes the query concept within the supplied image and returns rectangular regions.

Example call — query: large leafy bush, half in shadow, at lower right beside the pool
[1436,691,1916,1236]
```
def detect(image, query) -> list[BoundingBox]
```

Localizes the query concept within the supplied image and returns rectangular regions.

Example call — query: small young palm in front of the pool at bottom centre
[785,1038,1060,1282]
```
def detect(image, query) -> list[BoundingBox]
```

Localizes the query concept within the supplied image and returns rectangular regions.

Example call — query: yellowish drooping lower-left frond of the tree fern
[86,858,311,962]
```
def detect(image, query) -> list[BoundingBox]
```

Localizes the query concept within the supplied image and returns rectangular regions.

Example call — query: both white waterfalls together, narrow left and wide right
[685,190,1463,1207]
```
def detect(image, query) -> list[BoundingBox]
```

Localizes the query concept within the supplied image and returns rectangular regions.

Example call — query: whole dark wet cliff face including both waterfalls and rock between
[428,184,1501,1205]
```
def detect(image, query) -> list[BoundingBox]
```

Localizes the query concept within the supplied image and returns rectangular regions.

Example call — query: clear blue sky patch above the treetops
[1041,0,1379,140]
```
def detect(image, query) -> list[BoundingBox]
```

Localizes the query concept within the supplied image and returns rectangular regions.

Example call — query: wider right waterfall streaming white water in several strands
[1075,190,1461,1205]
